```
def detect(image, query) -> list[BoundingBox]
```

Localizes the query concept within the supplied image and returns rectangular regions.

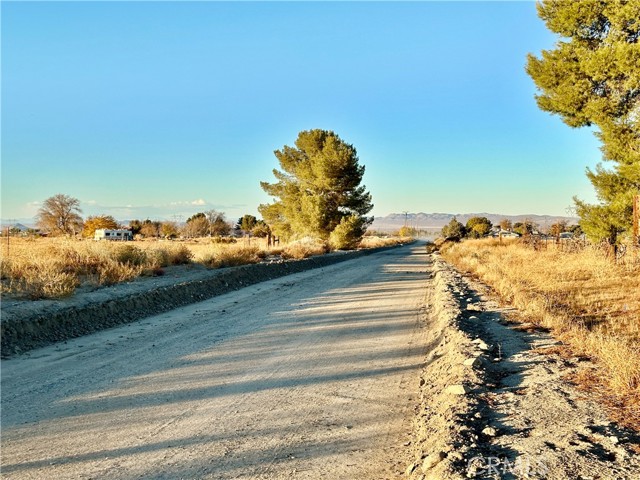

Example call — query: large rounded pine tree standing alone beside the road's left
[258,129,373,240]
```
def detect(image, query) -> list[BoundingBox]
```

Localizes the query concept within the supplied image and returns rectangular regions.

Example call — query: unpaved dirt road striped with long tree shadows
[2,246,427,479]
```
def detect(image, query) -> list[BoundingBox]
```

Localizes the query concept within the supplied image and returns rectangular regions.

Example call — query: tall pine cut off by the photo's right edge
[527,0,640,245]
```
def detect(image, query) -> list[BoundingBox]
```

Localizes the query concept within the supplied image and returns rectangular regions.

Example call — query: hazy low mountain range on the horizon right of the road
[370,213,578,232]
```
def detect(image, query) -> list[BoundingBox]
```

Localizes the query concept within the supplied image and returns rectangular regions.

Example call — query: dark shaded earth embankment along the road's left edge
[0,247,395,357]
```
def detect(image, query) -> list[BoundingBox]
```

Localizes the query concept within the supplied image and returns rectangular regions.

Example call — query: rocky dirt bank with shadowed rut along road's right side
[406,255,640,480]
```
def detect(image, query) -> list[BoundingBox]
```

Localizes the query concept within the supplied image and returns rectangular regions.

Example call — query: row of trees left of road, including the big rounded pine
[37,129,373,249]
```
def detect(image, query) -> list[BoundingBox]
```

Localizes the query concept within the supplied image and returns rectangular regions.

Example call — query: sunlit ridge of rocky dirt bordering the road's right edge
[406,254,481,480]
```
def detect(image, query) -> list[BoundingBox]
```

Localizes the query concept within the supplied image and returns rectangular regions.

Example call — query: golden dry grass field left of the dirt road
[0,233,409,300]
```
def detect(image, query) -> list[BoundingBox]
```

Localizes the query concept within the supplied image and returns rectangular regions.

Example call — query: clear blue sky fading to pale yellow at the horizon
[0,1,601,221]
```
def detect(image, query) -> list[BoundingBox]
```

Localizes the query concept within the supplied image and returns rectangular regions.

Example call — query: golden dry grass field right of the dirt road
[441,240,640,428]
